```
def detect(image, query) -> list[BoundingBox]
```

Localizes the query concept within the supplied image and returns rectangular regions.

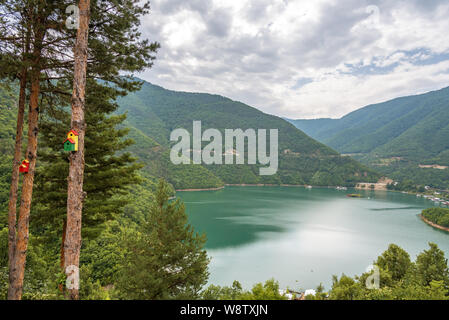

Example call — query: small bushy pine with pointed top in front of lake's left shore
[116,180,209,300]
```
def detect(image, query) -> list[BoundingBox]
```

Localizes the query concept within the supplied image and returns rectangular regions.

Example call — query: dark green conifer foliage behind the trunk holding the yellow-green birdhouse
[31,79,142,255]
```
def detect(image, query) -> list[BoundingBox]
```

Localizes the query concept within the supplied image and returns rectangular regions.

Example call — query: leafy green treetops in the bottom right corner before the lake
[329,243,449,300]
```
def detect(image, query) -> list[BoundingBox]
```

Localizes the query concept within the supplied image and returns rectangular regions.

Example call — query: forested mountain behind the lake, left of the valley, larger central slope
[118,82,379,189]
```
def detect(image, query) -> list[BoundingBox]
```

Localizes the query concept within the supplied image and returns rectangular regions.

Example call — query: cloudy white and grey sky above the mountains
[139,0,449,118]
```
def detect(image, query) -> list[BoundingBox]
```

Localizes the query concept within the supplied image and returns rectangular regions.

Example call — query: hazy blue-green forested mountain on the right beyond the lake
[289,87,449,187]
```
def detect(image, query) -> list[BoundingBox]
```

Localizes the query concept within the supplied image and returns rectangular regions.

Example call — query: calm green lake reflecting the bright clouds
[177,187,449,290]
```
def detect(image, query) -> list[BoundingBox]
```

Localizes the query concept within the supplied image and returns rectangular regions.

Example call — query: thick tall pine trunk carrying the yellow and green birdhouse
[64,0,90,300]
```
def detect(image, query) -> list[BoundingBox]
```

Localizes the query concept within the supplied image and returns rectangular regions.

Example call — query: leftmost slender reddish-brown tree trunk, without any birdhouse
[8,67,27,299]
